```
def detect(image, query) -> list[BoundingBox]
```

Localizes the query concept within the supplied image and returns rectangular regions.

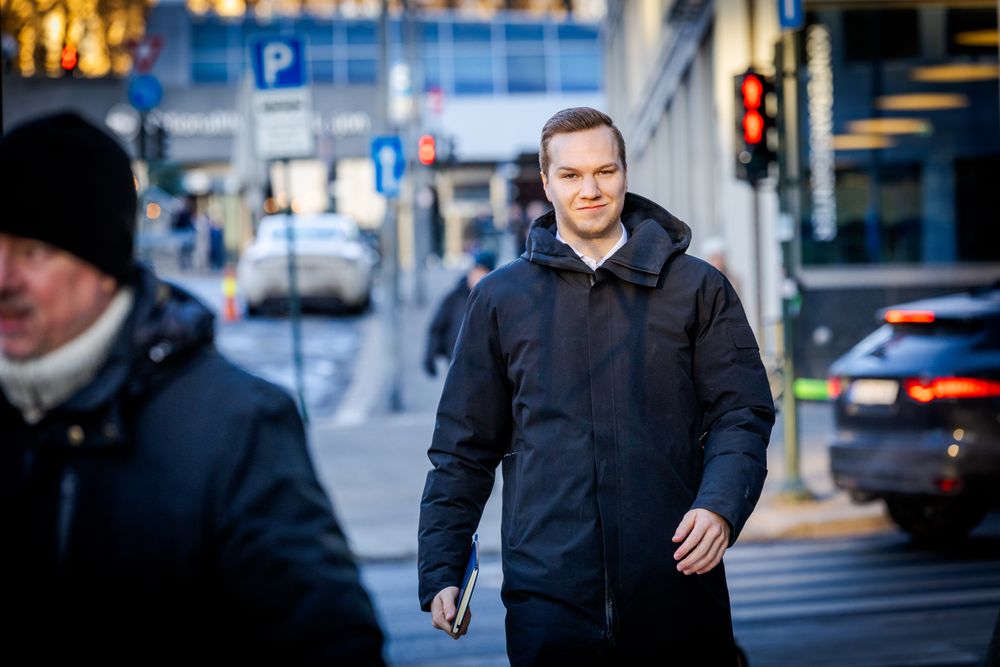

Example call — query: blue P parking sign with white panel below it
[250,36,315,160]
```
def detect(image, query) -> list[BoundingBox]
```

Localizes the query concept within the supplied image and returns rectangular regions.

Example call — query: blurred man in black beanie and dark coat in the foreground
[0,113,383,665]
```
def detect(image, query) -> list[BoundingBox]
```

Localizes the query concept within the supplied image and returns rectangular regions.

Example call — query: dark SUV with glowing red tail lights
[830,282,1000,540]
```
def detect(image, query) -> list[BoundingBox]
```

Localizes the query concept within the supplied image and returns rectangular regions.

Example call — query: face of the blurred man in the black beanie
[0,233,117,361]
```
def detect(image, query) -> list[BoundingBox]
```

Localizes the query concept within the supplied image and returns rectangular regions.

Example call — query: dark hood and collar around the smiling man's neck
[521,192,691,287]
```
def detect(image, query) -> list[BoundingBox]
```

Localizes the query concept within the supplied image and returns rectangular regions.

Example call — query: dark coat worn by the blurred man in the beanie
[0,270,382,665]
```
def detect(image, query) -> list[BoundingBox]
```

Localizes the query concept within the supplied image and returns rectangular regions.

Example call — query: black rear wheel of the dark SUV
[885,496,987,542]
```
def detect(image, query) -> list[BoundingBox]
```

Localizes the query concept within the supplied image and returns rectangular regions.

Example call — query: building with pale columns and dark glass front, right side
[605,0,1000,378]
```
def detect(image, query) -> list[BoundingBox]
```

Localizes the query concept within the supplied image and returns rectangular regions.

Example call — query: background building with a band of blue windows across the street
[4,0,604,261]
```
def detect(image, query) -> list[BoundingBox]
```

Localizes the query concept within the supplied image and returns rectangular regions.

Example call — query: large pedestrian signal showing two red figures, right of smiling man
[736,68,777,183]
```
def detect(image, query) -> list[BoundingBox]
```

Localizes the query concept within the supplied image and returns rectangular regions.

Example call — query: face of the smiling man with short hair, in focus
[542,125,628,244]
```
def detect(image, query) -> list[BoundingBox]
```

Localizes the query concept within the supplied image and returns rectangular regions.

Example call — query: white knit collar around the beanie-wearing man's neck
[0,287,132,424]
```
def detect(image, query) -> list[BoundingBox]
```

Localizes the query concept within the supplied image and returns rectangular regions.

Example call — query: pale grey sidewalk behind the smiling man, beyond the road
[311,260,891,560]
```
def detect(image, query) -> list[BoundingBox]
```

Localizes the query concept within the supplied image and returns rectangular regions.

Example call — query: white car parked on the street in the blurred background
[237,213,378,315]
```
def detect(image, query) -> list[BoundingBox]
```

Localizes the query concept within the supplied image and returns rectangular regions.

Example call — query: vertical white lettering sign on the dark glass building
[806,25,837,241]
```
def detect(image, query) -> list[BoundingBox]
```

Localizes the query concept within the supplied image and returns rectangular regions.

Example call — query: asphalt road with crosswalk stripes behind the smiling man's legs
[363,515,1000,667]
